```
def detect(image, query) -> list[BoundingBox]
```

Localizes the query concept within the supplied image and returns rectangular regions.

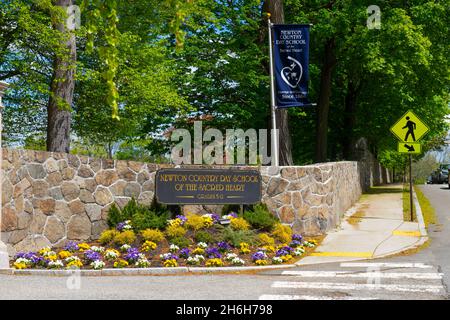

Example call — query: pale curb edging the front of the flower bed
[0,264,296,277]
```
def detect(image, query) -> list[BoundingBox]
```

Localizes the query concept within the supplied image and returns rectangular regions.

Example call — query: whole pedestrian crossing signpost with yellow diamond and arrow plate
[391,110,430,221]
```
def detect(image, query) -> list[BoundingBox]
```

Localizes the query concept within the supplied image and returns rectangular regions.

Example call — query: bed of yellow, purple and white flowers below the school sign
[11,204,317,270]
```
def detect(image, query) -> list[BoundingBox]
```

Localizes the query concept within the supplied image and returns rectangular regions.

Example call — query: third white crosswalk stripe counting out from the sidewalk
[272,281,445,293]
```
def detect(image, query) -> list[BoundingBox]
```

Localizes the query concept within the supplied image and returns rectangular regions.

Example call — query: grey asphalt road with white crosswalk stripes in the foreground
[0,185,450,300]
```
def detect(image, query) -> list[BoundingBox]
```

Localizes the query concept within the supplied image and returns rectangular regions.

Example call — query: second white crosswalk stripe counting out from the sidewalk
[281,271,443,280]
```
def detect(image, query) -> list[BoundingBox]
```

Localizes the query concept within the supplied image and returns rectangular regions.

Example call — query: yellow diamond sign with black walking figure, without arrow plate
[391,110,430,142]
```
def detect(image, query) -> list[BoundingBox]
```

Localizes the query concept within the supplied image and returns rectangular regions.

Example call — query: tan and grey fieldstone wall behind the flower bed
[1,149,384,254]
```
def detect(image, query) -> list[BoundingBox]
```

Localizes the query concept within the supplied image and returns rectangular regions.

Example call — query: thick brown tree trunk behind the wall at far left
[47,0,77,153]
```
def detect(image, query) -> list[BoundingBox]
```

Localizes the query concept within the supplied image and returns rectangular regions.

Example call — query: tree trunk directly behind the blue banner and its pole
[262,0,293,166]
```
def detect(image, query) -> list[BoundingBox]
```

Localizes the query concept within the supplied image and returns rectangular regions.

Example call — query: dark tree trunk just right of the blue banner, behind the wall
[315,38,336,162]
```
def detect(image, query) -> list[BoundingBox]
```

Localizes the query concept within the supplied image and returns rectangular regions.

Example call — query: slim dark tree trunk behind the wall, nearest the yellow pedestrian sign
[342,80,358,160]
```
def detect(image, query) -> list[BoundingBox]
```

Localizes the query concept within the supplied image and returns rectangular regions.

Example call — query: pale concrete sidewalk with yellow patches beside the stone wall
[297,185,428,265]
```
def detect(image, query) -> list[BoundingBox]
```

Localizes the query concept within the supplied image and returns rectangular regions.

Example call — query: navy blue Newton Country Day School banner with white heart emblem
[272,24,310,108]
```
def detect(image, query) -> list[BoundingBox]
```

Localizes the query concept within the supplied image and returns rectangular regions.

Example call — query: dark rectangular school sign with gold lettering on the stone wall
[155,169,262,204]
